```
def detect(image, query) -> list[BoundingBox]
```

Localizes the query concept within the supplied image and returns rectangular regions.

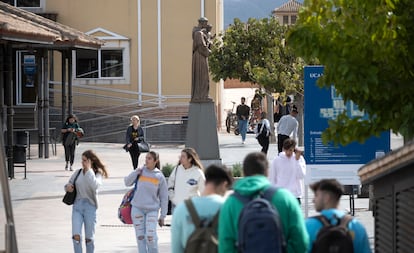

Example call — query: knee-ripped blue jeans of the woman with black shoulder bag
[72,199,96,253]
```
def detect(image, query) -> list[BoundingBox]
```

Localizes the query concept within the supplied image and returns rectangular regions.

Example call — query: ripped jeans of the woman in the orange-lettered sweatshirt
[131,206,158,253]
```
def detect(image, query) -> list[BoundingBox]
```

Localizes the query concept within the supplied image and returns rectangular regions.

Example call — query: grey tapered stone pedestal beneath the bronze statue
[185,102,221,168]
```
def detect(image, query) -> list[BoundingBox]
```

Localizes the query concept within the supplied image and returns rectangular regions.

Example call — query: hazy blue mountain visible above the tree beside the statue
[223,0,303,28]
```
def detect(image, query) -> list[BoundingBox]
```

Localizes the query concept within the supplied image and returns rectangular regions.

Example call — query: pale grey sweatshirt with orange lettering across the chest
[124,166,168,219]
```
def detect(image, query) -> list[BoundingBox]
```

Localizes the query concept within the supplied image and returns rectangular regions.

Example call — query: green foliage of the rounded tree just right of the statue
[209,18,304,93]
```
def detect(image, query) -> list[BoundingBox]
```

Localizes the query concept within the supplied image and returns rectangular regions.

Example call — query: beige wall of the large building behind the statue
[46,0,222,103]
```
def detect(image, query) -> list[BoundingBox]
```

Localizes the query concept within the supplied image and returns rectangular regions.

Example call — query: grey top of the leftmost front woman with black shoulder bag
[65,169,102,208]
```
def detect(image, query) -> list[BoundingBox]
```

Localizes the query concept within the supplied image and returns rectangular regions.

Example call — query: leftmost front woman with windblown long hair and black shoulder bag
[65,150,108,253]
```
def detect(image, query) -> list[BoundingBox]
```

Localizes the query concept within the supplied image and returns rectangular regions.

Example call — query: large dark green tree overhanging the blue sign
[287,0,414,145]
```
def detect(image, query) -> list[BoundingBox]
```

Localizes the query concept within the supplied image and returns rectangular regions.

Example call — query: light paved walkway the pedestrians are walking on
[0,133,374,253]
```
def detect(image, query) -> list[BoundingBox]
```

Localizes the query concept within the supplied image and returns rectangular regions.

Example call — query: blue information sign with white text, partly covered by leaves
[304,66,390,185]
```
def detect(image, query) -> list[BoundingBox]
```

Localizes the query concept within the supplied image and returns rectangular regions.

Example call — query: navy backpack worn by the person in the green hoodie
[233,186,287,253]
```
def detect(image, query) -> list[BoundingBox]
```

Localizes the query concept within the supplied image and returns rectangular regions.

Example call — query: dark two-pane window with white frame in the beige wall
[76,49,124,78]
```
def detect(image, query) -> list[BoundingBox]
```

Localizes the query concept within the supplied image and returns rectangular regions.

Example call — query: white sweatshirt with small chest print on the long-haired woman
[168,165,206,205]
